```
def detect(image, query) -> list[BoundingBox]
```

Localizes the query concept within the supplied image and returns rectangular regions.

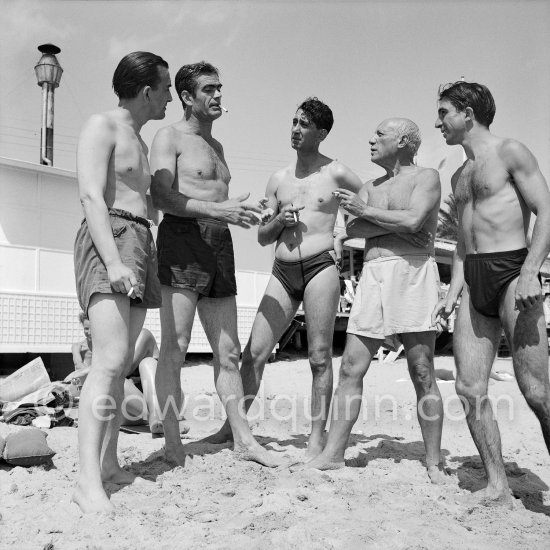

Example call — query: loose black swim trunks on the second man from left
[157,214,237,298]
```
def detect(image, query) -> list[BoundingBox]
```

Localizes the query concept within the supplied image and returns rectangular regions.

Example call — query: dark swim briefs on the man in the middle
[271,250,336,302]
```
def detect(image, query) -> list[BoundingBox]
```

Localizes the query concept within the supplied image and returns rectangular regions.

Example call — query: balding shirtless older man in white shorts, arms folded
[305,118,445,483]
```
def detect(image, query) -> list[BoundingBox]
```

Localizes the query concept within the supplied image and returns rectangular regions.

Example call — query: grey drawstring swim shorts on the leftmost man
[74,208,162,314]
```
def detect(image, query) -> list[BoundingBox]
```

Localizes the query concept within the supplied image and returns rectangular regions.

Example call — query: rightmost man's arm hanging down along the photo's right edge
[501,140,550,311]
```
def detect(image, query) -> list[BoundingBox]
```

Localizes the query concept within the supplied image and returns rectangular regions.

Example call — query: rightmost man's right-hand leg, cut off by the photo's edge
[500,280,550,452]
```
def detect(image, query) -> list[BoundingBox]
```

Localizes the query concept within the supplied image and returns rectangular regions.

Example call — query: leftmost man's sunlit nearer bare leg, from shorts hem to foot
[73,294,140,513]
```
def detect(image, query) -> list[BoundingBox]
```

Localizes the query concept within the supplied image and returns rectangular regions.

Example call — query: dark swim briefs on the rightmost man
[464,248,541,317]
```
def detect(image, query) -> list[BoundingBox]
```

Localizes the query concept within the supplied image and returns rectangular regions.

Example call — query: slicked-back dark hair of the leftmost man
[113,52,168,99]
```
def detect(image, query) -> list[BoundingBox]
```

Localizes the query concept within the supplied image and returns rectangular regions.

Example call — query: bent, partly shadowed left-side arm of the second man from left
[151,127,260,227]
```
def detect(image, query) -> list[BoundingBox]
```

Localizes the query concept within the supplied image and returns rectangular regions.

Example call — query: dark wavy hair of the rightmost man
[439,80,496,128]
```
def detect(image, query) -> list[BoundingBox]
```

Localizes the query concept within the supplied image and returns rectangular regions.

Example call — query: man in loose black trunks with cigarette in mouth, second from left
[151,61,276,466]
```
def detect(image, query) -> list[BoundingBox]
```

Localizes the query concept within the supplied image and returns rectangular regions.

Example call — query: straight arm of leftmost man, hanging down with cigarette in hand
[77,115,137,293]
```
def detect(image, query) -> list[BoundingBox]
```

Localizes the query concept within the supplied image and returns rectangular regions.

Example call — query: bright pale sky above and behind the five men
[0,0,550,269]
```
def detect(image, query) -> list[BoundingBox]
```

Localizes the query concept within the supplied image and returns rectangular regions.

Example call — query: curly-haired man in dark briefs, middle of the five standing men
[208,98,362,458]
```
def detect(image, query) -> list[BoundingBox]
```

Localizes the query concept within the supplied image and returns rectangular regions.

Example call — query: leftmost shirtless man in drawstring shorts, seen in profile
[73,52,172,512]
